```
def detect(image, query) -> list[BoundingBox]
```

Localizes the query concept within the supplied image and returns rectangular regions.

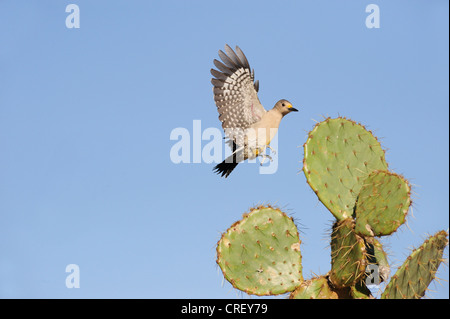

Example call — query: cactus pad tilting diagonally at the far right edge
[381,230,448,299]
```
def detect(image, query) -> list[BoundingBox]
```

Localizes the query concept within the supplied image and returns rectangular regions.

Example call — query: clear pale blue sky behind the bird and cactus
[0,0,449,298]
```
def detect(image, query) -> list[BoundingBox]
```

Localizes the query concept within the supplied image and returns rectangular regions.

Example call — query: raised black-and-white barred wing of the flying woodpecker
[211,44,266,146]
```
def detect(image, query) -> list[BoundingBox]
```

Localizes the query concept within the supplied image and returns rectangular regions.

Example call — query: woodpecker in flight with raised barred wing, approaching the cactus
[211,44,298,178]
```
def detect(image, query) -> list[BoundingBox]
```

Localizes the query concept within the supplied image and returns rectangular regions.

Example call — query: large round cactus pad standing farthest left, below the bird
[217,206,303,296]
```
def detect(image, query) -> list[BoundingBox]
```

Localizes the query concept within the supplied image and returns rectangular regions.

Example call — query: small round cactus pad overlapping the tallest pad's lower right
[355,171,411,236]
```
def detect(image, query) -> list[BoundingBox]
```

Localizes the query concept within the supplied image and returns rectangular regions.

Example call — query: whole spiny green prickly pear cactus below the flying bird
[217,117,448,299]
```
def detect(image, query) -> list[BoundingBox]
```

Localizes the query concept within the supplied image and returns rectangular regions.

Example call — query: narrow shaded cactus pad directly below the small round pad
[365,237,391,285]
